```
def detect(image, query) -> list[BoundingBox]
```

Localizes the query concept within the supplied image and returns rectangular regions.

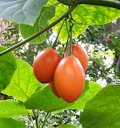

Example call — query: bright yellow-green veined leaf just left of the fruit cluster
[2,60,41,101]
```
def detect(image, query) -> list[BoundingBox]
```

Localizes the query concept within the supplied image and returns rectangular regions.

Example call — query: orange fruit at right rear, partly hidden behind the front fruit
[64,44,89,71]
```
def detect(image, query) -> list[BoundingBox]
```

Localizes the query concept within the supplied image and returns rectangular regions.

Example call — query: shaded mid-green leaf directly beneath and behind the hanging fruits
[25,81,92,112]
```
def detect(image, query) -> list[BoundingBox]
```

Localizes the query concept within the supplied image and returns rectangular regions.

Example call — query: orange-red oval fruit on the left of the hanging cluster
[33,48,61,83]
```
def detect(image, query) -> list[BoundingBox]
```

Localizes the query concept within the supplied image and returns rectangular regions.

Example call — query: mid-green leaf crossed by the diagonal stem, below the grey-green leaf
[20,5,55,44]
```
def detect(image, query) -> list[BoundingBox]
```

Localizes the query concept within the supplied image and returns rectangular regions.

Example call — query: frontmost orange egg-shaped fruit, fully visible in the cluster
[54,55,85,103]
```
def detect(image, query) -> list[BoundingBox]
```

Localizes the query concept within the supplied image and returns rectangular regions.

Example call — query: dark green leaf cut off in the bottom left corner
[0,118,26,128]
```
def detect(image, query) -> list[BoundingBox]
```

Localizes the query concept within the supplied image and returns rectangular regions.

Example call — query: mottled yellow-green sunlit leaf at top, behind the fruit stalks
[51,1,120,43]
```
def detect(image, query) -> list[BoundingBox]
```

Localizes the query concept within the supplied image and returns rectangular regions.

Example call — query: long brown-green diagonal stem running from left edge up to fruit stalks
[0,4,77,56]
